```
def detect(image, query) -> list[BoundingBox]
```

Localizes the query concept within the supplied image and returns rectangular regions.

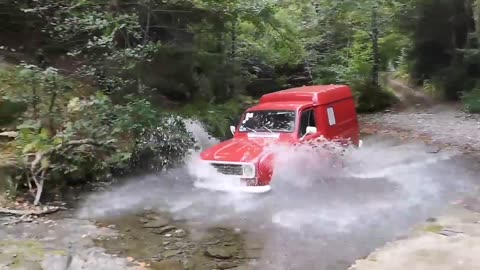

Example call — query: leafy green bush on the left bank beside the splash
[0,65,194,204]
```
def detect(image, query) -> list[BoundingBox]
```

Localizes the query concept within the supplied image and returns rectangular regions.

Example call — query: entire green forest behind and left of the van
[0,0,480,204]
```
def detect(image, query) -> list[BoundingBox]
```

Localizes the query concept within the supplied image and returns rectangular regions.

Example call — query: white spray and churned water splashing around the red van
[79,122,474,270]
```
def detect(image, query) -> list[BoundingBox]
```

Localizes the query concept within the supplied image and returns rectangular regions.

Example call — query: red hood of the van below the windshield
[201,138,278,162]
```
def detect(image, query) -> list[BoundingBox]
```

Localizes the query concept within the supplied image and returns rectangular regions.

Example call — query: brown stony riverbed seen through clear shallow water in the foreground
[96,212,261,270]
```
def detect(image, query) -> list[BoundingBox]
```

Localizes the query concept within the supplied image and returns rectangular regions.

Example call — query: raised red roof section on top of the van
[260,84,352,107]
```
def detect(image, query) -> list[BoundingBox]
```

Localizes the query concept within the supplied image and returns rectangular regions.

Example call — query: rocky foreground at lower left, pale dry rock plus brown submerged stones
[0,207,261,270]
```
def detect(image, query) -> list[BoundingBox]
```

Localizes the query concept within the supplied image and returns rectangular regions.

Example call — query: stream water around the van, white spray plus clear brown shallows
[77,123,475,270]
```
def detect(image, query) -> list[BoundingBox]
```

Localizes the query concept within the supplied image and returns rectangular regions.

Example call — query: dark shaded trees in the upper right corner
[396,0,480,101]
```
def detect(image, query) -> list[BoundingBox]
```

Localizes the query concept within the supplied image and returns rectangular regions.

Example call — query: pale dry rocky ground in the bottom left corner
[0,218,139,270]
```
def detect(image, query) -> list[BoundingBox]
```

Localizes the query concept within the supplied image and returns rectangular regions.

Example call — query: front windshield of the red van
[239,111,296,133]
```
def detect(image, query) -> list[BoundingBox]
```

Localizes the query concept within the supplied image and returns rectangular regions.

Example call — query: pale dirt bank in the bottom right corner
[349,207,480,270]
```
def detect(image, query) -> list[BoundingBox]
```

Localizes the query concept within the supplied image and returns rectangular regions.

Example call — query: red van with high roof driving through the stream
[200,85,361,192]
